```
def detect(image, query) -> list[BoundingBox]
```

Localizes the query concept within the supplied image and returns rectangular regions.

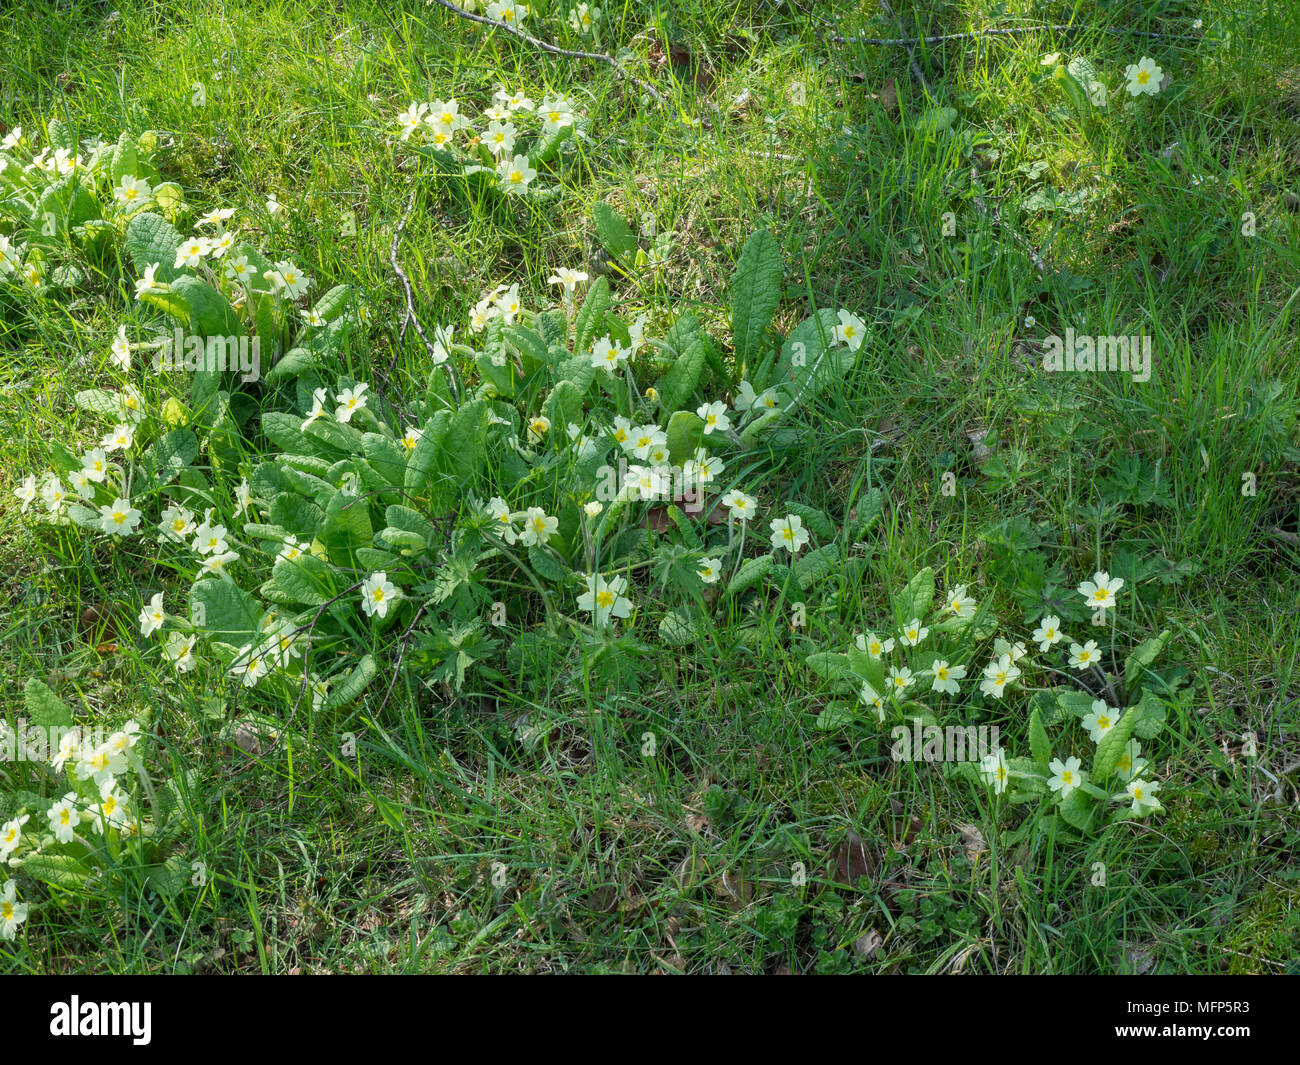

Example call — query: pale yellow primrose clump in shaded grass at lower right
[807,567,1171,830]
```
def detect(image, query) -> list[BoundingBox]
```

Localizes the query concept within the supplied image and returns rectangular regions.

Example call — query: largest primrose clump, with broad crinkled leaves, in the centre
[17,189,880,713]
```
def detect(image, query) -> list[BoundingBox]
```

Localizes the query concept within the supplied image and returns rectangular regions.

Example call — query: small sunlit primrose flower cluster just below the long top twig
[397,87,580,196]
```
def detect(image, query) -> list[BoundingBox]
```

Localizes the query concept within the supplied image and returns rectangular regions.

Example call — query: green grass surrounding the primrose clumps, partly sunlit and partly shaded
[0,0,1300,973]
